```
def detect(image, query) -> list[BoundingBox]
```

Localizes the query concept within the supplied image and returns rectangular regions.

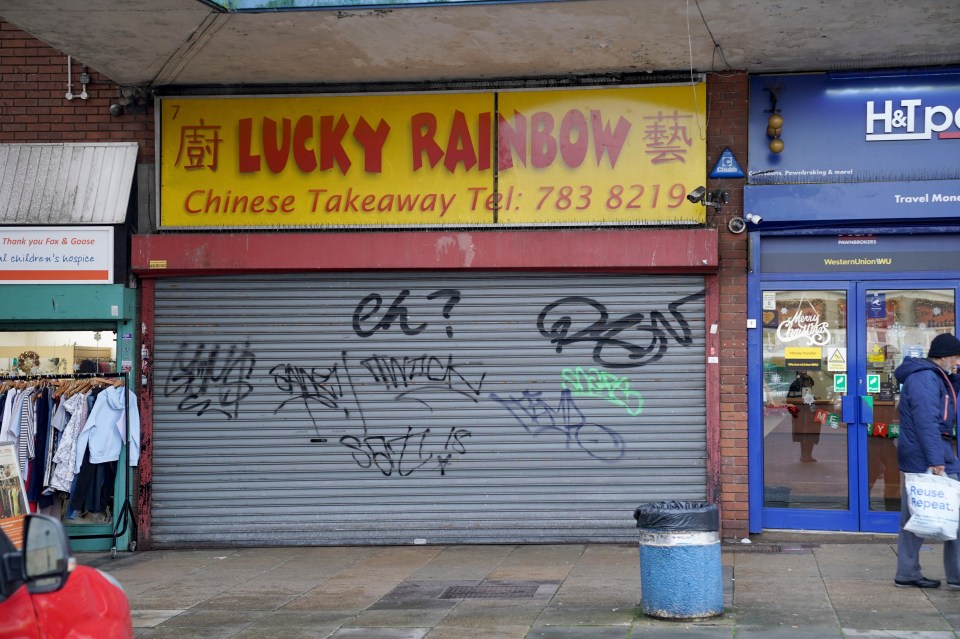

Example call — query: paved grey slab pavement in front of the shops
[77,536,960,639]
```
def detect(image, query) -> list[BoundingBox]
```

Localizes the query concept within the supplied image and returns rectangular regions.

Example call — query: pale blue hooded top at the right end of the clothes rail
[75,386,140,473]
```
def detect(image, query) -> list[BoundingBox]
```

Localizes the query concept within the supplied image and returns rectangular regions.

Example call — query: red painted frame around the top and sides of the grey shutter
[131,229,721,549]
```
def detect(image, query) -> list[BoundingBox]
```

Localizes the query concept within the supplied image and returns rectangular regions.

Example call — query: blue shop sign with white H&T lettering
[748,69,960,184]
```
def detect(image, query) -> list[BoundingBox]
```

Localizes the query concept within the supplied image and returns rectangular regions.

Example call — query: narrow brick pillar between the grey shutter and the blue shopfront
[707,73,749,538]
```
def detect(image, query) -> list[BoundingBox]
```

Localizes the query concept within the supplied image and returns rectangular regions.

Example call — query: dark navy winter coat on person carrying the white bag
[893,357,960,474]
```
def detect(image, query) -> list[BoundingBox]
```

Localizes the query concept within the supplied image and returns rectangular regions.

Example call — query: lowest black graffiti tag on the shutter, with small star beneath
[340,426,470,477]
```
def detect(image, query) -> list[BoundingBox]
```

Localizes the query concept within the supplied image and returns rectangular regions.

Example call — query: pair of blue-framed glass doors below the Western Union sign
[748,278,958,532]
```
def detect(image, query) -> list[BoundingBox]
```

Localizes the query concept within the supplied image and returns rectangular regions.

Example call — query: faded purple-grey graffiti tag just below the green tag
[490,389,624,462]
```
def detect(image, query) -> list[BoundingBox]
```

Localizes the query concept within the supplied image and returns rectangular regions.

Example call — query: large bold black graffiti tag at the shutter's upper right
[537,291,705,368]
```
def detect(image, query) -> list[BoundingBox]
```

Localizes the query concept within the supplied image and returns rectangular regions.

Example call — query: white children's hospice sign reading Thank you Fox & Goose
[0,226,114,284]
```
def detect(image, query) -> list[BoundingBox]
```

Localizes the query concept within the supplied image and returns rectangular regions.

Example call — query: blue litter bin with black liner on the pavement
[633,501,723,619]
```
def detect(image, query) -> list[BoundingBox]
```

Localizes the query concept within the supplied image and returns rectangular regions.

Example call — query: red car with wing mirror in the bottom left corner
[0,515,133,639]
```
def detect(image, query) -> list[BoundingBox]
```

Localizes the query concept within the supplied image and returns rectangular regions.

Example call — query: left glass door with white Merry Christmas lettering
[759,283,859,530]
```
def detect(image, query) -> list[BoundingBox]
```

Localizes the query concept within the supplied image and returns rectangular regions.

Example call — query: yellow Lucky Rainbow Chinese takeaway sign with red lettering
[160,85,706,228]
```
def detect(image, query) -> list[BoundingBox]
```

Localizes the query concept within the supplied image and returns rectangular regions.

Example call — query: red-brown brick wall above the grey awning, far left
[0,21,154,162]
